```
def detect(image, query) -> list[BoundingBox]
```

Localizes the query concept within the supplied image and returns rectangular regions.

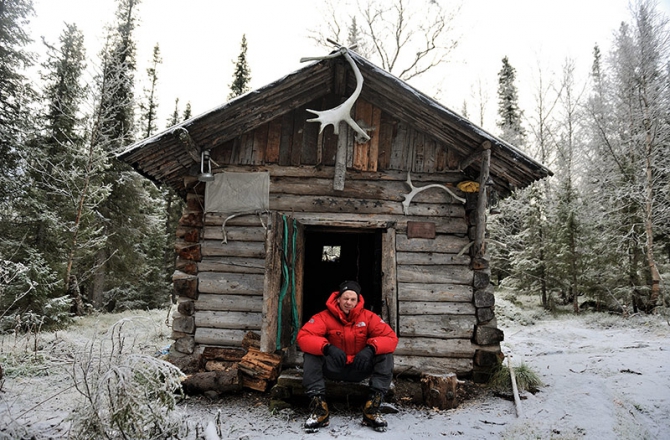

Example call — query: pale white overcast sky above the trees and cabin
[25,0,670,131]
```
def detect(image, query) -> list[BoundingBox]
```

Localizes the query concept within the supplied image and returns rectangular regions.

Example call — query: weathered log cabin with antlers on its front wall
[118,48,551,382]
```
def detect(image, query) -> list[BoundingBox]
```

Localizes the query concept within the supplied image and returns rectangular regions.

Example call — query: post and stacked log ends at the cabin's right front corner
[465,142,504,383]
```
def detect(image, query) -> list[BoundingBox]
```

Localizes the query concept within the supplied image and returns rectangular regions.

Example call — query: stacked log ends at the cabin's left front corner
[168,178,204,373]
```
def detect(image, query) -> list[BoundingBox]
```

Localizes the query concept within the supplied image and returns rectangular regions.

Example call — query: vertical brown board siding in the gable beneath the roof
[212,95,459,173]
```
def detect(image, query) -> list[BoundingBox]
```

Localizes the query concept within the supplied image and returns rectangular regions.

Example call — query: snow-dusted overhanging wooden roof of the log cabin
[117,52,552,194]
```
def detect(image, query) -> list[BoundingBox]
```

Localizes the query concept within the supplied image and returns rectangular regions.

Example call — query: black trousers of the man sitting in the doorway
[302,353,393,396]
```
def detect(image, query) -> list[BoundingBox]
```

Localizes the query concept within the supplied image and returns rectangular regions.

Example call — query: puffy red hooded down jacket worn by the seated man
[297,291,398,364]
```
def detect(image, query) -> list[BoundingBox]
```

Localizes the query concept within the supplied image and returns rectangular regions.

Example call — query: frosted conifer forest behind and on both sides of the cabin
[0,0,670,330]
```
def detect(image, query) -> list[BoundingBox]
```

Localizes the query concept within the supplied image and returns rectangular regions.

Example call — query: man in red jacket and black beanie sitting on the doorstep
[297,281,398,432]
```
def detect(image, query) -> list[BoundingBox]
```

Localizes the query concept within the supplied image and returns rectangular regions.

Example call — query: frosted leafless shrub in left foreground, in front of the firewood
[70,320,183,440]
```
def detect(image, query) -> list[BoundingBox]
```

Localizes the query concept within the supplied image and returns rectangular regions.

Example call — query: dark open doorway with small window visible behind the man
[302,228,382,323]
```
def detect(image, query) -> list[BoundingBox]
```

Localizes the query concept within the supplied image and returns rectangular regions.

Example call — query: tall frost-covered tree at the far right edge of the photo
[589,1,670,311]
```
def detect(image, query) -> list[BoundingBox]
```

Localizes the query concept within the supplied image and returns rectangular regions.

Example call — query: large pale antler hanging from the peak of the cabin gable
[300,46,370,143]
